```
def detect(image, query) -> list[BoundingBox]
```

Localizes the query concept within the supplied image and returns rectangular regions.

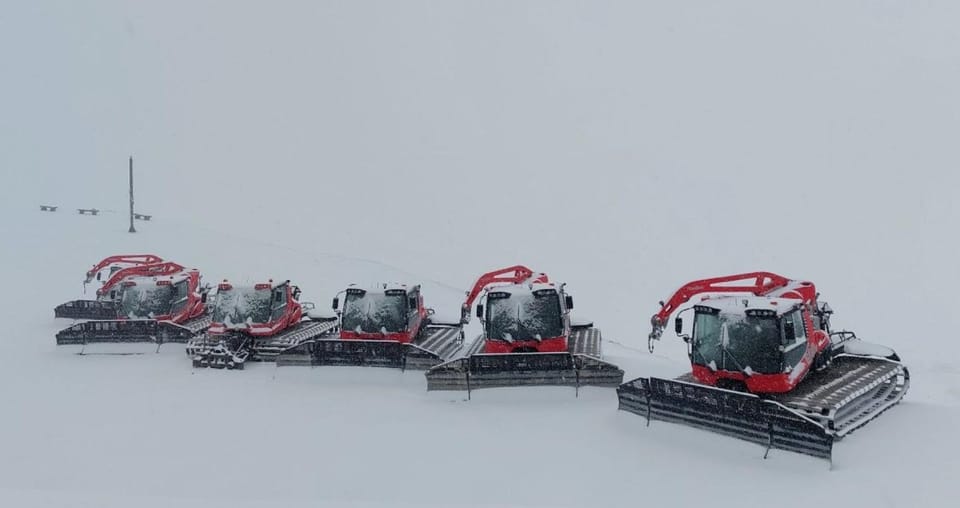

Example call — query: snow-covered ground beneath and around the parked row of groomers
[0,210,960,506]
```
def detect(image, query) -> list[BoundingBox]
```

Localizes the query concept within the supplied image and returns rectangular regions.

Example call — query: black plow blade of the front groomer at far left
[57,316,210,354]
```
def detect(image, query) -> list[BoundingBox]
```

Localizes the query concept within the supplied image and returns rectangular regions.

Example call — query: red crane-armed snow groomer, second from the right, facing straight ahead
[426,265,623,392]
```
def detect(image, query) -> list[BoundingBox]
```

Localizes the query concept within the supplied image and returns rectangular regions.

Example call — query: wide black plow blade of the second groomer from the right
[426,353,623,392]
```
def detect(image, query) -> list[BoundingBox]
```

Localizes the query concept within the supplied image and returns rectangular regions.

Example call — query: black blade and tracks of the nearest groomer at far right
[617,355,910,460]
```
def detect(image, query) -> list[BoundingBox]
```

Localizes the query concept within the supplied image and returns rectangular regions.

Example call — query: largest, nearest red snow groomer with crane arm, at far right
[617,272,910,458]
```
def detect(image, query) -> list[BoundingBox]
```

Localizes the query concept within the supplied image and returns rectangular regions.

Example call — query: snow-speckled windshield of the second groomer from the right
[487,290,563,342]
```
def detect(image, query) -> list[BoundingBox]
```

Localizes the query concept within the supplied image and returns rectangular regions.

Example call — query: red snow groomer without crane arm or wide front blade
[187,279,336,369]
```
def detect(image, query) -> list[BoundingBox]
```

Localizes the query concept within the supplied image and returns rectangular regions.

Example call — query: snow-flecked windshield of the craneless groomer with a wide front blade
[342,291,407,333]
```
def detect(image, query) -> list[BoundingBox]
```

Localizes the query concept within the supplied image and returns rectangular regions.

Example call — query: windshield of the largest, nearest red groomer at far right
[693,312,782,374]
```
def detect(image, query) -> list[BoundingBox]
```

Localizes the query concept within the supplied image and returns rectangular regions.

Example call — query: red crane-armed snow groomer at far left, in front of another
[57,262,210,354]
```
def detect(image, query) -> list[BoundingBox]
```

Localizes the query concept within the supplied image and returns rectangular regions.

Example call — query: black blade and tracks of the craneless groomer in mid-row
[277,326,463,370]
